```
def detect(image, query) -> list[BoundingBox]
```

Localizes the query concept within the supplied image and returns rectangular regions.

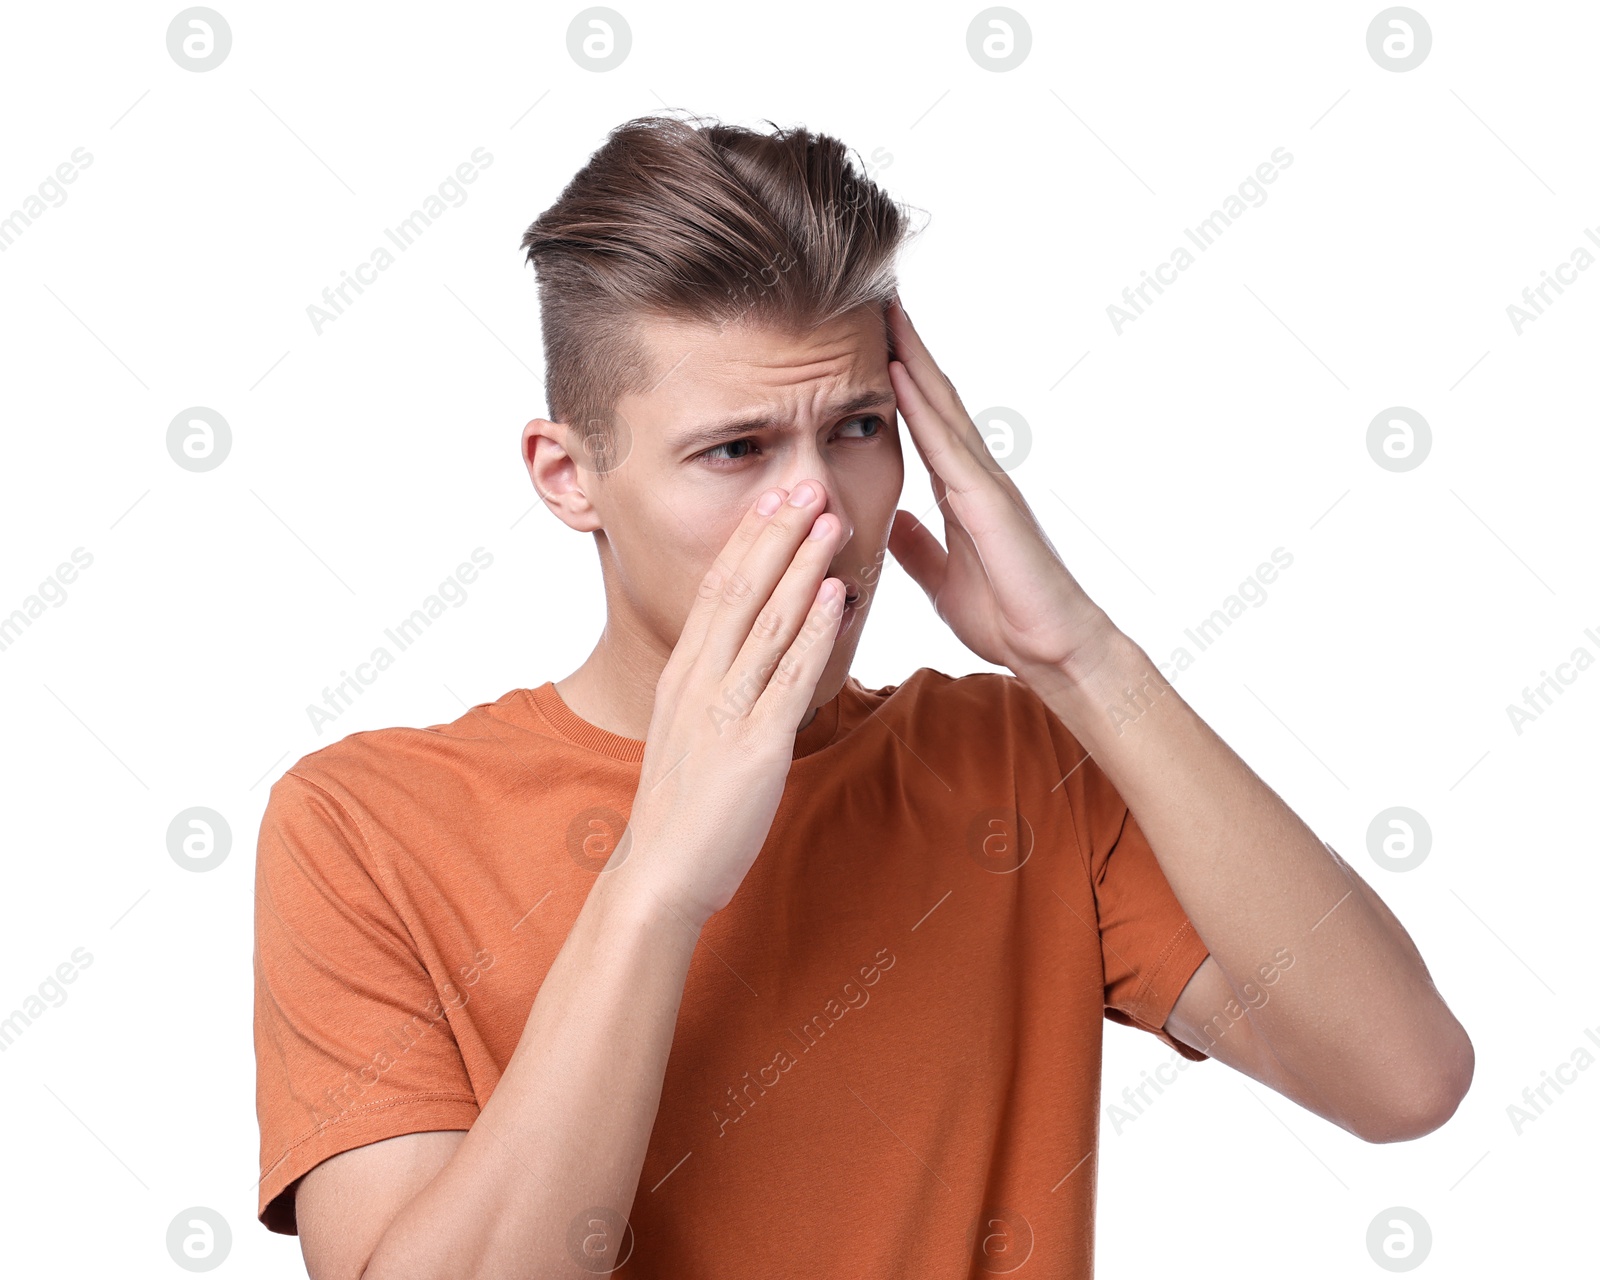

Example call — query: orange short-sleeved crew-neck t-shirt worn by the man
[254,667,1208,1280]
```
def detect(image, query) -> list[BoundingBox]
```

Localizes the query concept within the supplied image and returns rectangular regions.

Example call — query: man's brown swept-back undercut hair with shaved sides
[522,114,920,475]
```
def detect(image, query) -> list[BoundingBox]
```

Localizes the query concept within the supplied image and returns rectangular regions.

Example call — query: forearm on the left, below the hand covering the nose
[363,850,699,1280]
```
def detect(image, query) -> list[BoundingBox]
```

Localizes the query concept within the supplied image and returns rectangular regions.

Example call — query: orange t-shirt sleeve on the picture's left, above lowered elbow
[254,771,478,1235]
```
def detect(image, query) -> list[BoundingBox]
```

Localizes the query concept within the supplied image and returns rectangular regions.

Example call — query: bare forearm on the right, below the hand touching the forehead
[1027,632,1470,1114]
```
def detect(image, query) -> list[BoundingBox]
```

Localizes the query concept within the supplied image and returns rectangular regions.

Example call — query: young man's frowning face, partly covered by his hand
[547,306,906,706]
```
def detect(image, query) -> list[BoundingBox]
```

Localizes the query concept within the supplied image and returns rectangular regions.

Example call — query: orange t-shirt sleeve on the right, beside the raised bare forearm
[1045,694,1211,1062]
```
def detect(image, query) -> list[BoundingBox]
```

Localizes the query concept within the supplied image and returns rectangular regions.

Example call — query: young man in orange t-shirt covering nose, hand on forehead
[256,118,1472,1280]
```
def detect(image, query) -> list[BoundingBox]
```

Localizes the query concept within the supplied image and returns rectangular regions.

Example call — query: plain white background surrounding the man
[0,0,1600,1277]
